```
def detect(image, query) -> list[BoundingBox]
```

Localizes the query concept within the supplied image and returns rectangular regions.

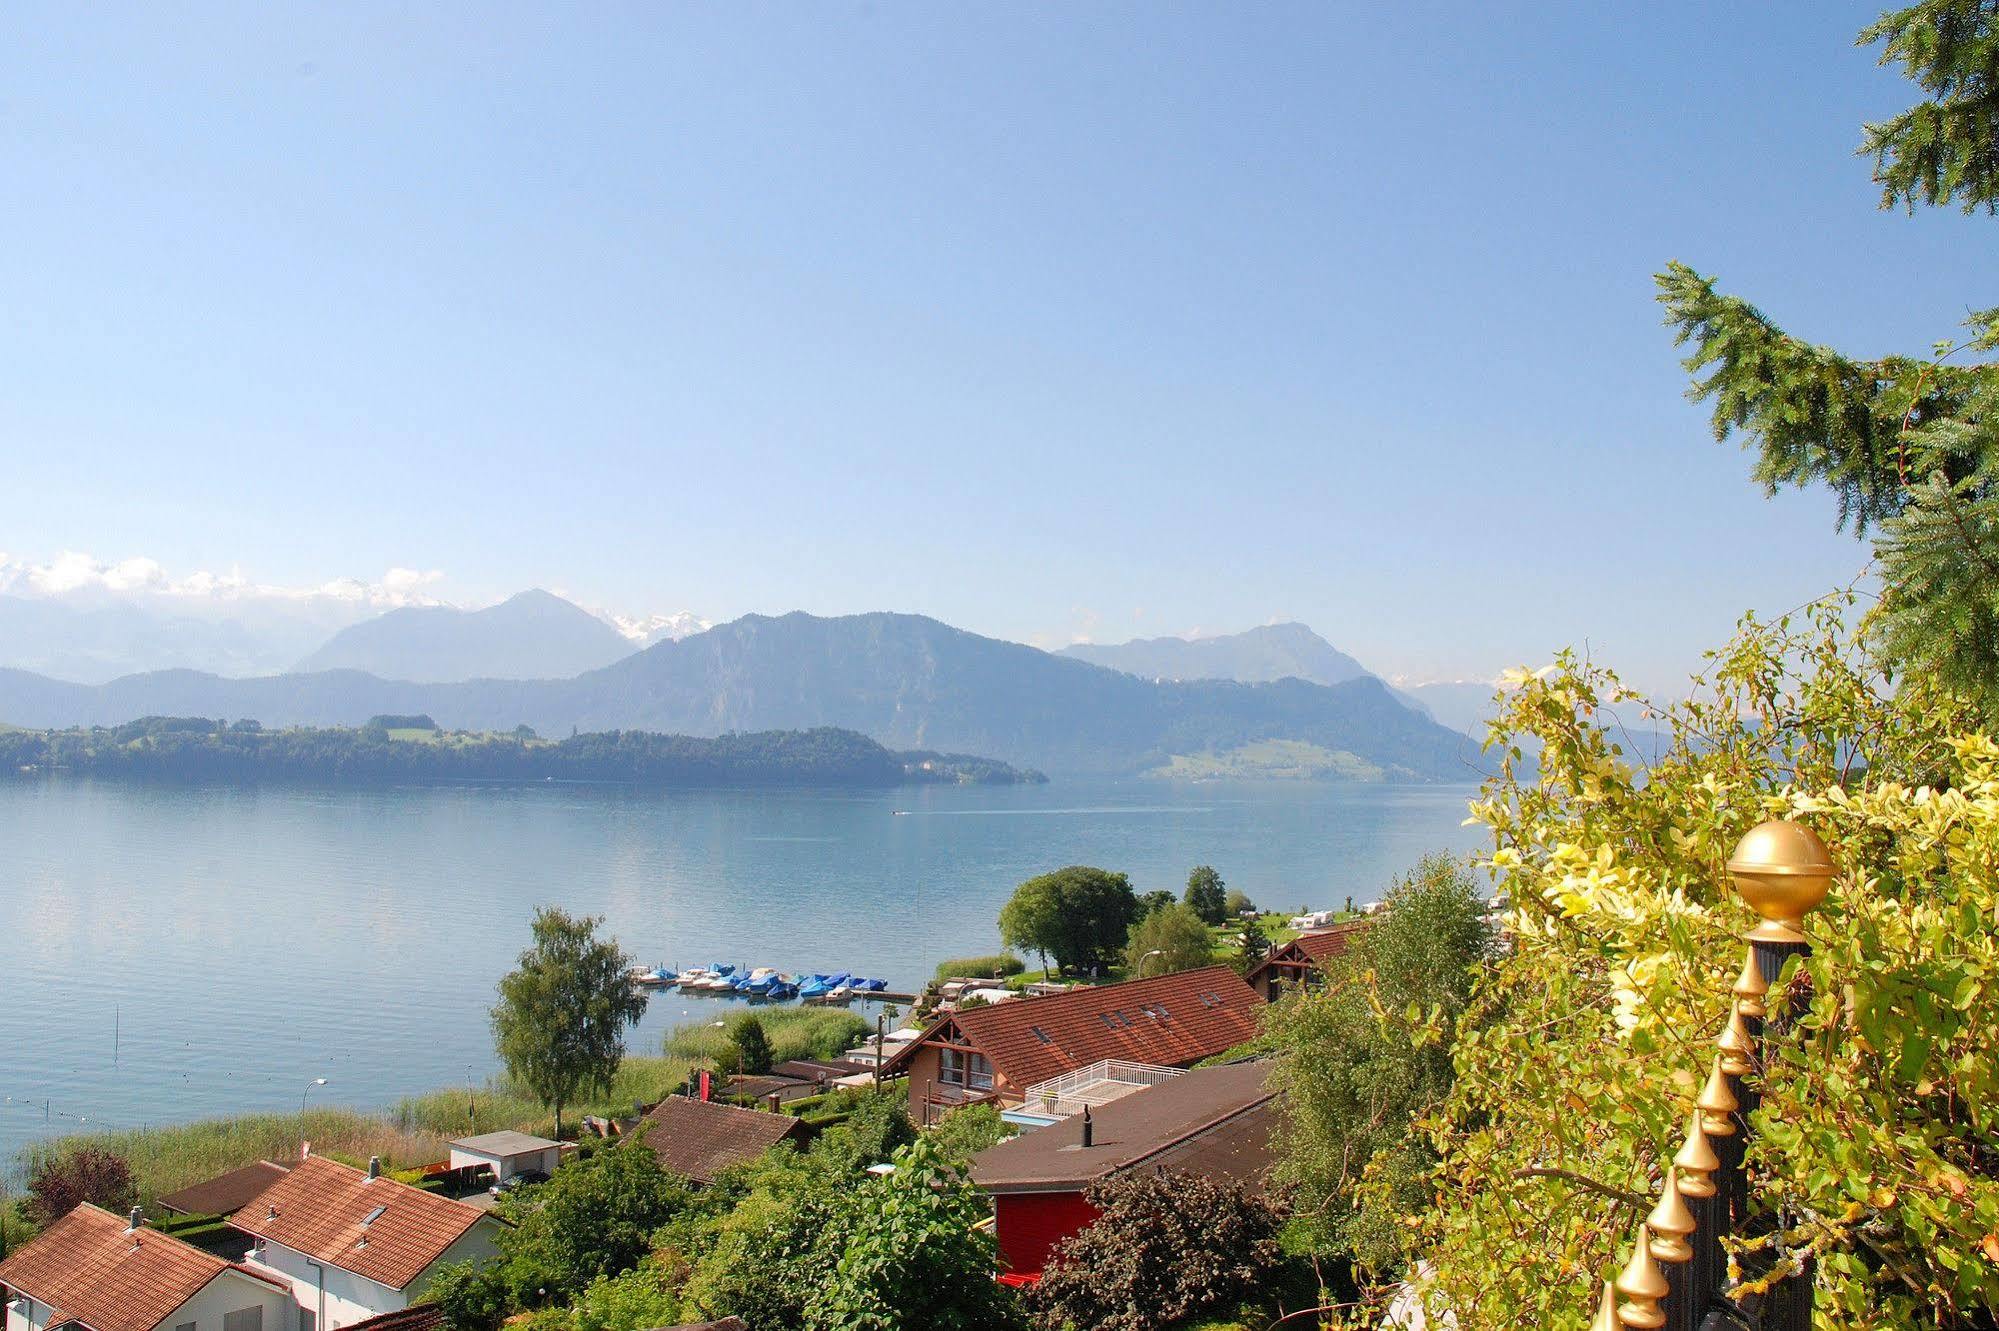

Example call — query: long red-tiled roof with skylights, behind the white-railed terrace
[884,965,1263,1091]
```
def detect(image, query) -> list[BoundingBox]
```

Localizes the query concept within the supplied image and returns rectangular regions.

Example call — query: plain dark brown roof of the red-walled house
[972,1063,1275,1193]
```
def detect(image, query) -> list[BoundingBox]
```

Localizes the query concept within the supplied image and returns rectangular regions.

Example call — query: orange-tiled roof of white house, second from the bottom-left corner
[230,1155,486,1289]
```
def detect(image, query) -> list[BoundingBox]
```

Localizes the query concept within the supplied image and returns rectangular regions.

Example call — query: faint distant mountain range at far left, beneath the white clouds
[0,596,301,683]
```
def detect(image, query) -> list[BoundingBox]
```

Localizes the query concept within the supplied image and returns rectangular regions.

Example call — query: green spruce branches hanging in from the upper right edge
[1657,0,1999,717]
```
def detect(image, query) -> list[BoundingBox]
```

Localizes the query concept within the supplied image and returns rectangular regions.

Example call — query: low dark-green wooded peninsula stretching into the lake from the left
[0,715,1045,787]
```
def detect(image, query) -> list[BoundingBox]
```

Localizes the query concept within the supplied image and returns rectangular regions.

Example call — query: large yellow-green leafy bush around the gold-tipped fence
[1405,598,1999,1331]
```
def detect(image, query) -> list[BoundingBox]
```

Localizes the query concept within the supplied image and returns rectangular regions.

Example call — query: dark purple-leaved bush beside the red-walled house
[1027,1173,1281,1331]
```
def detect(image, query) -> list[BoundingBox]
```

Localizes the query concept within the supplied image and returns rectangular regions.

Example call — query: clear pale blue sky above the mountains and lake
[0,10,1995,681]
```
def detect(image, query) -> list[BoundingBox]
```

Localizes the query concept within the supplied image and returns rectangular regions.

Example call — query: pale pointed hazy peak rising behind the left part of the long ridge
[298,590,636,683]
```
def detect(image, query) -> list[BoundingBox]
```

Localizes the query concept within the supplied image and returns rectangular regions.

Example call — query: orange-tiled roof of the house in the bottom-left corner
[0,1203,286,1331]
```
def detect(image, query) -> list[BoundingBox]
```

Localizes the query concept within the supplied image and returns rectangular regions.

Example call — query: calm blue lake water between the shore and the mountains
[0,781,1483,1167]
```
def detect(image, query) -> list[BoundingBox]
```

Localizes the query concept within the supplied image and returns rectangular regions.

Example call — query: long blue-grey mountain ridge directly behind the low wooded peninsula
[0,614,1475,779]
